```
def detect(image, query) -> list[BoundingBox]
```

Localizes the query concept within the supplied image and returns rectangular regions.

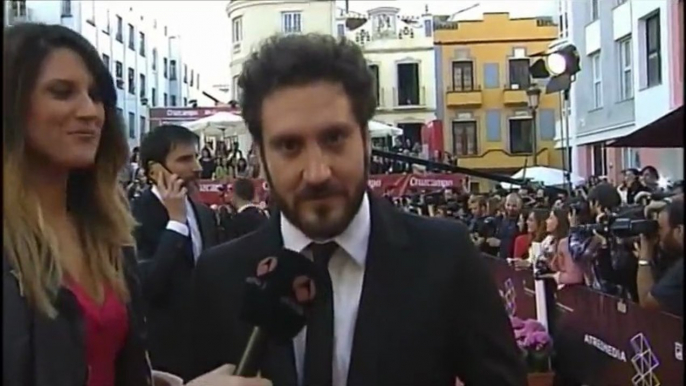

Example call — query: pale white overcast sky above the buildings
[133,0,556,88]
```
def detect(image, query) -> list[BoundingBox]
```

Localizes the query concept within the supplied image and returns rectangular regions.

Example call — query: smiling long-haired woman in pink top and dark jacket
[2,23,270,386]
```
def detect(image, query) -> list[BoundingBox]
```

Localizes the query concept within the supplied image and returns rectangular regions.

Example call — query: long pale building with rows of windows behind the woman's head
[4,0,208,147]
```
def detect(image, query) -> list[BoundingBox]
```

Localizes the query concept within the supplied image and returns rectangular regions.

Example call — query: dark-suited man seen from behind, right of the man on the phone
[226,178,267,240]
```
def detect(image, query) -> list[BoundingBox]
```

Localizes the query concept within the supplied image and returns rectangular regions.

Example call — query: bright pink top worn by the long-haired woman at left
[67,281,129,386]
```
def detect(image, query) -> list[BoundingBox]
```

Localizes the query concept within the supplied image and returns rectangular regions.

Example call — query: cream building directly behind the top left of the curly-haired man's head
[226,0,336,100]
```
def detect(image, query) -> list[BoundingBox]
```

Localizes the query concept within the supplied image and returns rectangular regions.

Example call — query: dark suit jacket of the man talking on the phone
[132,189,217,375]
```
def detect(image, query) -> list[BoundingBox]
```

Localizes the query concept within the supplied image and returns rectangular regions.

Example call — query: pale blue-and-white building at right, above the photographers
[557,0,683,181]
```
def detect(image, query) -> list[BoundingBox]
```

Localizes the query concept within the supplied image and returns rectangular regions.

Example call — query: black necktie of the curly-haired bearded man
[303,242,338,386]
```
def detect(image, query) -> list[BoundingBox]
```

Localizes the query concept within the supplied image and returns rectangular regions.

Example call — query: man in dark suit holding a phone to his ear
[132,125,217,375]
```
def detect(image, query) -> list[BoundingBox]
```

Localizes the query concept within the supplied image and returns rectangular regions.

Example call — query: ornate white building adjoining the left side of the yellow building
[336,7,436,148]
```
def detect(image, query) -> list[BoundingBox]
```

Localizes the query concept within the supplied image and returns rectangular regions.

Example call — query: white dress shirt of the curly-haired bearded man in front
[281,194,371,386]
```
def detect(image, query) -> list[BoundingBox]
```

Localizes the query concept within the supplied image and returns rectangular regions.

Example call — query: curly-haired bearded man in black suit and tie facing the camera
[191,34,527,386]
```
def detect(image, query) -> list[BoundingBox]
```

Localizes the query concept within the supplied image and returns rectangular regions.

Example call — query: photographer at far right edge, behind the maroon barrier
[637,199,684,316]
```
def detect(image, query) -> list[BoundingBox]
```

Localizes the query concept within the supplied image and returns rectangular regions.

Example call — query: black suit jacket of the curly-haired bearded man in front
[190,198,527,386]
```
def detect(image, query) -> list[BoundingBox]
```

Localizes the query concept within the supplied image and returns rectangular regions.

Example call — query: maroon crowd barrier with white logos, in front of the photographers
[485,255,684,386]
